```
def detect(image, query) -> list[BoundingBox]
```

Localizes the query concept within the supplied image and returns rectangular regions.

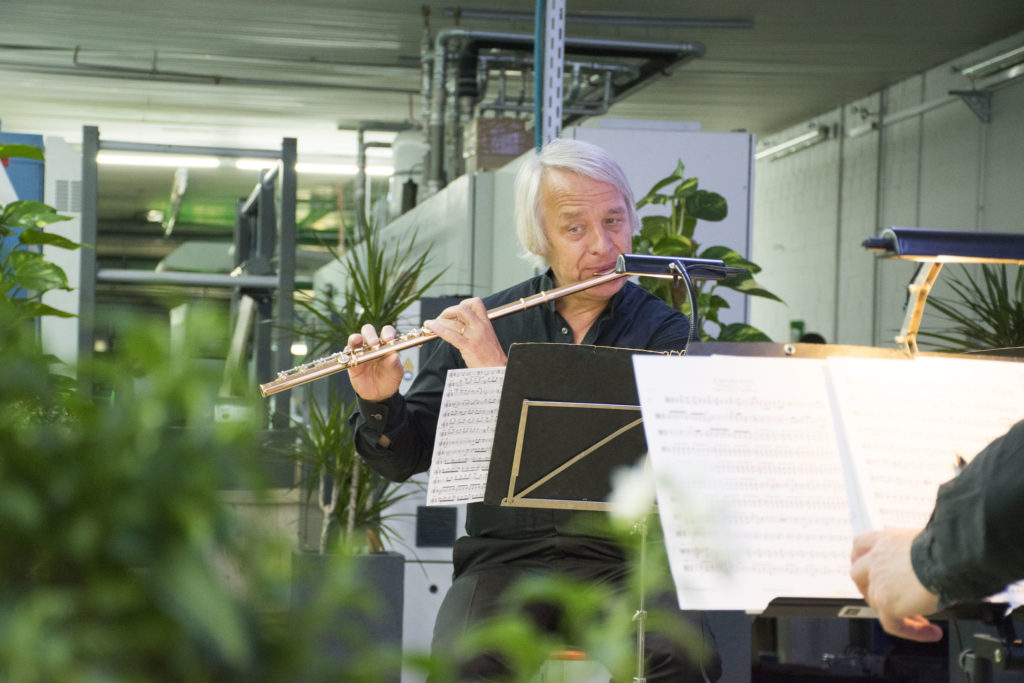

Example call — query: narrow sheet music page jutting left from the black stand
[427,368,505,505]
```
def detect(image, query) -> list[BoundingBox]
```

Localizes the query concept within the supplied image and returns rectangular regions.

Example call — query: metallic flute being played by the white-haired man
[259,271,630,397]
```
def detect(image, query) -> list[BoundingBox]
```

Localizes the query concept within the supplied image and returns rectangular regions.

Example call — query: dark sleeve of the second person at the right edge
[910,421,1024,607]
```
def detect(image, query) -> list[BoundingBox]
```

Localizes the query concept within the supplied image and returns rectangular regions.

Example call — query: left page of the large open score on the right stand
[634,356,859,611]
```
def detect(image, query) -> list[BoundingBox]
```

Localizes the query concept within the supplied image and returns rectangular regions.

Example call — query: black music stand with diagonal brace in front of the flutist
[483,343,667,683]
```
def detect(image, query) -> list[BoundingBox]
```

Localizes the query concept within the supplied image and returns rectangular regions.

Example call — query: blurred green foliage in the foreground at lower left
[0,297,712,683]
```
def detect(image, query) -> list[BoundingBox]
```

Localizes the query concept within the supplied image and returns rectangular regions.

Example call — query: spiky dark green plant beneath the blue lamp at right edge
[919,263,1024,355]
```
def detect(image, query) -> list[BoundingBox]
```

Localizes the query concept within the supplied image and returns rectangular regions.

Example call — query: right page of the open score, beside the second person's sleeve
[827,356,1024,531]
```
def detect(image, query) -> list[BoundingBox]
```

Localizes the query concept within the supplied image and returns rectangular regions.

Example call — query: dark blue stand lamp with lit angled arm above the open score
[863,227,1024,356]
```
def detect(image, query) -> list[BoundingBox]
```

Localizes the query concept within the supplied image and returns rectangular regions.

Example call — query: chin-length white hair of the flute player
[515,138,640,266]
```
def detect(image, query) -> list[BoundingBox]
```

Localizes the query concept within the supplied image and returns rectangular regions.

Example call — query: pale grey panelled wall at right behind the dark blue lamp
[751,34,1024,347]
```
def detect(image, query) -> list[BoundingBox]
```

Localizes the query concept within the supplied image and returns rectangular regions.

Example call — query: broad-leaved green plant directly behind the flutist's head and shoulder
[633,161,782,341]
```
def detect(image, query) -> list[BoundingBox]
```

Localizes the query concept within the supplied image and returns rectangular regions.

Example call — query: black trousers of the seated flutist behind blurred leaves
[432,562,721,683]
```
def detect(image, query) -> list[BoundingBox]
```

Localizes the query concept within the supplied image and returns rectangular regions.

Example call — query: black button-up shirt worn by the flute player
[354,271,689,574]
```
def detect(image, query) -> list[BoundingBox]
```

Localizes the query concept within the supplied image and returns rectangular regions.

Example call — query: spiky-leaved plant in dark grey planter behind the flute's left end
[280,222,441,680]
